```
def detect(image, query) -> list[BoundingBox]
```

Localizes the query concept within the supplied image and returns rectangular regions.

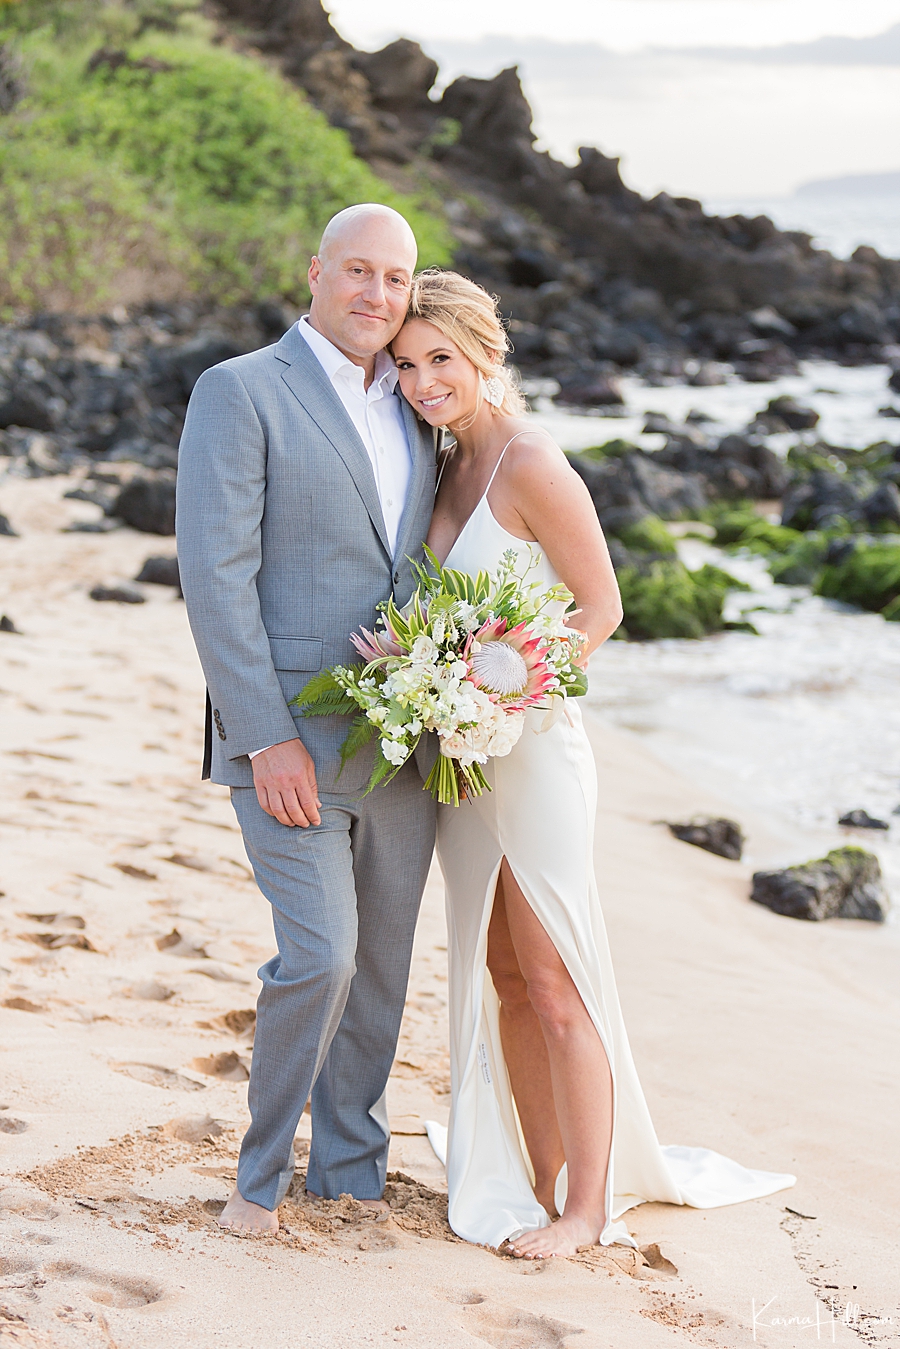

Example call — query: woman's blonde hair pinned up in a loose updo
[406,267,526,425]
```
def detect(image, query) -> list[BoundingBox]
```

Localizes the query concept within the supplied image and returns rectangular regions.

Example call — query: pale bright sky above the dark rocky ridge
[325,0,900,202]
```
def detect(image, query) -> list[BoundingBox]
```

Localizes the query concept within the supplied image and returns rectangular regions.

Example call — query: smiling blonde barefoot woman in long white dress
[393,271,793,1259]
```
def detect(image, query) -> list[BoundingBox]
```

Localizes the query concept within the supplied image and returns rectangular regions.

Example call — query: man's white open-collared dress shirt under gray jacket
[250,314,413,759]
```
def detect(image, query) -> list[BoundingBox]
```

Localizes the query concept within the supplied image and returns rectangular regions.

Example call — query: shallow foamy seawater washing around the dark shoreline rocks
[536,362,900,923]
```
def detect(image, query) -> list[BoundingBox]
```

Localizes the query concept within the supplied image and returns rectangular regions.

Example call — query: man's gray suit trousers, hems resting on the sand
[231,762,434,1209]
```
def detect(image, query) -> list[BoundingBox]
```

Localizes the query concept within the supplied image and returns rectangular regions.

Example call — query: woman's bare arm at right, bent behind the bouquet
[491,430,622,654]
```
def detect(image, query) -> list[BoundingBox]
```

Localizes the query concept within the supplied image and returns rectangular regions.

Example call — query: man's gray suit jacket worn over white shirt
[177,328,437,792]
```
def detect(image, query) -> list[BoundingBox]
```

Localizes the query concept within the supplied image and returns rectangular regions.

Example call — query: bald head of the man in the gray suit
[309,202,417,384]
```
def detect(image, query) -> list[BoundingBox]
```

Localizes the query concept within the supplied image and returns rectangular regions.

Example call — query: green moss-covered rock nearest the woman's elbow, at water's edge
[618,558,749,639]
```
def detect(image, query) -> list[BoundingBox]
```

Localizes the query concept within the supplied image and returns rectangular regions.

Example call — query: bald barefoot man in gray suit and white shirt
[178,205,436,1232]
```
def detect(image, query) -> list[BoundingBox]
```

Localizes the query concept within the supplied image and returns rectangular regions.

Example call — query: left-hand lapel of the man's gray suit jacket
[275,328,391,557]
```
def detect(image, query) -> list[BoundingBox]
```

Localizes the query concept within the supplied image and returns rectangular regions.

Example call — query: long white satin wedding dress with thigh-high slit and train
[428,437,795,1246]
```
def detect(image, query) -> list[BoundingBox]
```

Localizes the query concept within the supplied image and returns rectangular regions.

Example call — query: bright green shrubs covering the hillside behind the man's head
[0,10,451,305]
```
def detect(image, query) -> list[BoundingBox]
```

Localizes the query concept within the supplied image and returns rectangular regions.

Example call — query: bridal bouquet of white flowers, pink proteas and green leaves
[291,549,587,805]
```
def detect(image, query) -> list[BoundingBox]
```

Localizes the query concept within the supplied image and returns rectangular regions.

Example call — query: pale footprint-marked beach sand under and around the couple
[0,476,900,1349]
